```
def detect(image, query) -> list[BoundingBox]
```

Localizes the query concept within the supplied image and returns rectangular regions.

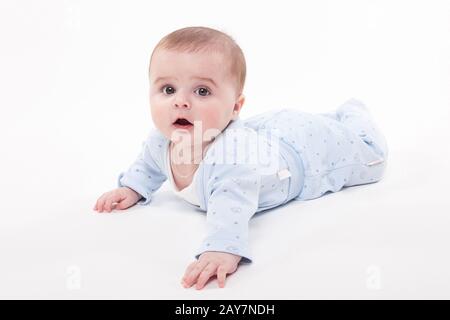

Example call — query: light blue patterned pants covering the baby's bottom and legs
[250,99,388,200]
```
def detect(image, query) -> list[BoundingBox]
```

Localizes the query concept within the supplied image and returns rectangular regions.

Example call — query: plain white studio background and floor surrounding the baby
[0,0,450,299]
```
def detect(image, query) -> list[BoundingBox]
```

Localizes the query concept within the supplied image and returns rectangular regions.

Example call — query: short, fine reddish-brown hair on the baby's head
[149,27,247,94]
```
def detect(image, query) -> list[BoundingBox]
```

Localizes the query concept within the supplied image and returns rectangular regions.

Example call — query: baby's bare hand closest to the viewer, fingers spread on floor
[181,251,242,290]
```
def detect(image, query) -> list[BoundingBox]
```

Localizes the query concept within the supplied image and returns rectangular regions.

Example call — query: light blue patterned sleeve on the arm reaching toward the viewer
[195,164,261,263]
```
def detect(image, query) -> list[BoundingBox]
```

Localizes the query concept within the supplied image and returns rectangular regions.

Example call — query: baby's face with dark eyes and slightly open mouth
[150,49,244,145]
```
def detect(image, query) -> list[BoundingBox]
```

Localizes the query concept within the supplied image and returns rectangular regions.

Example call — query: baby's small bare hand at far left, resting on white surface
[94,187,142,212]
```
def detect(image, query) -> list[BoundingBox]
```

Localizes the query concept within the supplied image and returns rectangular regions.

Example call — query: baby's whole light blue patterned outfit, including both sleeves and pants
[118,99,388,262]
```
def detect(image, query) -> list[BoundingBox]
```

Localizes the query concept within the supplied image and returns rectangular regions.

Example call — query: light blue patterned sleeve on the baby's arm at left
[117,134,167,205]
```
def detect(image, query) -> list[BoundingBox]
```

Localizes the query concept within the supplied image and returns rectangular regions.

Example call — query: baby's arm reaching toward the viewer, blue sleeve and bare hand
[181,165,261,289]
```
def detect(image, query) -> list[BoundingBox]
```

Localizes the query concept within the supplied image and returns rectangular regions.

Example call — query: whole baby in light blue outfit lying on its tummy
[94,27,388,289]
